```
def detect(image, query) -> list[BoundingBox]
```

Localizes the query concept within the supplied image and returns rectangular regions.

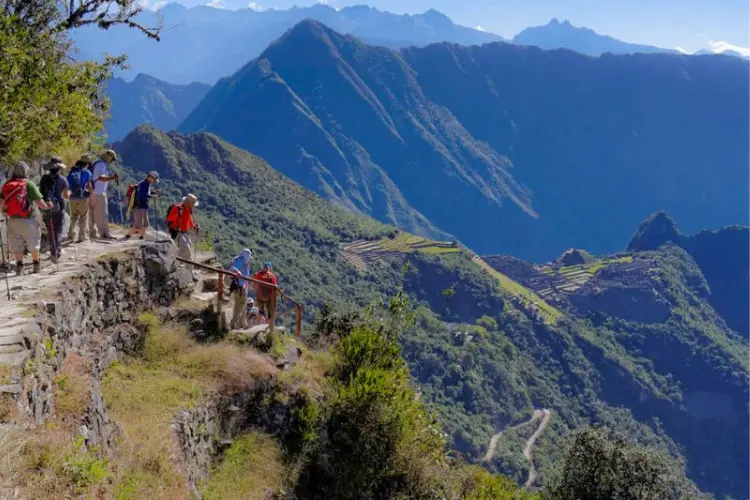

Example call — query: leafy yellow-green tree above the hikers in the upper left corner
[0,0,160,164]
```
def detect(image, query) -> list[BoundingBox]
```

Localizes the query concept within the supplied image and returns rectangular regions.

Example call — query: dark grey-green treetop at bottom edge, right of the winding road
[549,428,702,500]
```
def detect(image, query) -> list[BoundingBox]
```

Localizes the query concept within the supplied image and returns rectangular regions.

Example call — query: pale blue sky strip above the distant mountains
[159,0,750,52]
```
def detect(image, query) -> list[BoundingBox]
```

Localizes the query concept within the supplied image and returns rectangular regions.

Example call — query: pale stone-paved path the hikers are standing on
[0,228,214,394]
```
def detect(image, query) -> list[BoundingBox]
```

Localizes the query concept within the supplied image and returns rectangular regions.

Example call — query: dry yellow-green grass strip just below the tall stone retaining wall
[102,314,275,499]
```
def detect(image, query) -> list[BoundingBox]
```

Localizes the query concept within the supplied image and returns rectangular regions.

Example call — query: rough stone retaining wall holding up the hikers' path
[19,241,193,428]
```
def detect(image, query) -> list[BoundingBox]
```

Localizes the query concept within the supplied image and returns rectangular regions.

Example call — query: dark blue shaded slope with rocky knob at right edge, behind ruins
[628,212,750,337]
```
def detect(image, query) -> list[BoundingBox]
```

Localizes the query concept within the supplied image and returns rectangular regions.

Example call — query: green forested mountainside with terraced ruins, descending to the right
[116,126,748,496]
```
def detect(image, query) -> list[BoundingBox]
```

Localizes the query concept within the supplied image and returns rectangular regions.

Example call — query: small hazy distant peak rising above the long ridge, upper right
[513,19,678,56]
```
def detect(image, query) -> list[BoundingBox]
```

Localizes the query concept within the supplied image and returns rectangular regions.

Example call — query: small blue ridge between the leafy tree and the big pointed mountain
[104,74,211,141]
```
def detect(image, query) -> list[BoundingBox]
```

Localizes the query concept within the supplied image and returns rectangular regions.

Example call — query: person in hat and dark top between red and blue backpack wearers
[39,156,70,263]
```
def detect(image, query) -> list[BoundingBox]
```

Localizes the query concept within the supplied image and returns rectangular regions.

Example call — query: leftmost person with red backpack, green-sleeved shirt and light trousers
[0,161,49,276]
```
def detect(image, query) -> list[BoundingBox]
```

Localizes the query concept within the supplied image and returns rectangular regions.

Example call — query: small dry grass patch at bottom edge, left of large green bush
[201,432,285,500]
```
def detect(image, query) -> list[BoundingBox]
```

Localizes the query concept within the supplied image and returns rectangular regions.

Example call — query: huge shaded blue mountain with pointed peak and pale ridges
[180,21,750,261]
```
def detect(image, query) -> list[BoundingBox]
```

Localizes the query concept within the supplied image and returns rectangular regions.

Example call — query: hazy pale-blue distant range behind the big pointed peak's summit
[72,3,502,84]
